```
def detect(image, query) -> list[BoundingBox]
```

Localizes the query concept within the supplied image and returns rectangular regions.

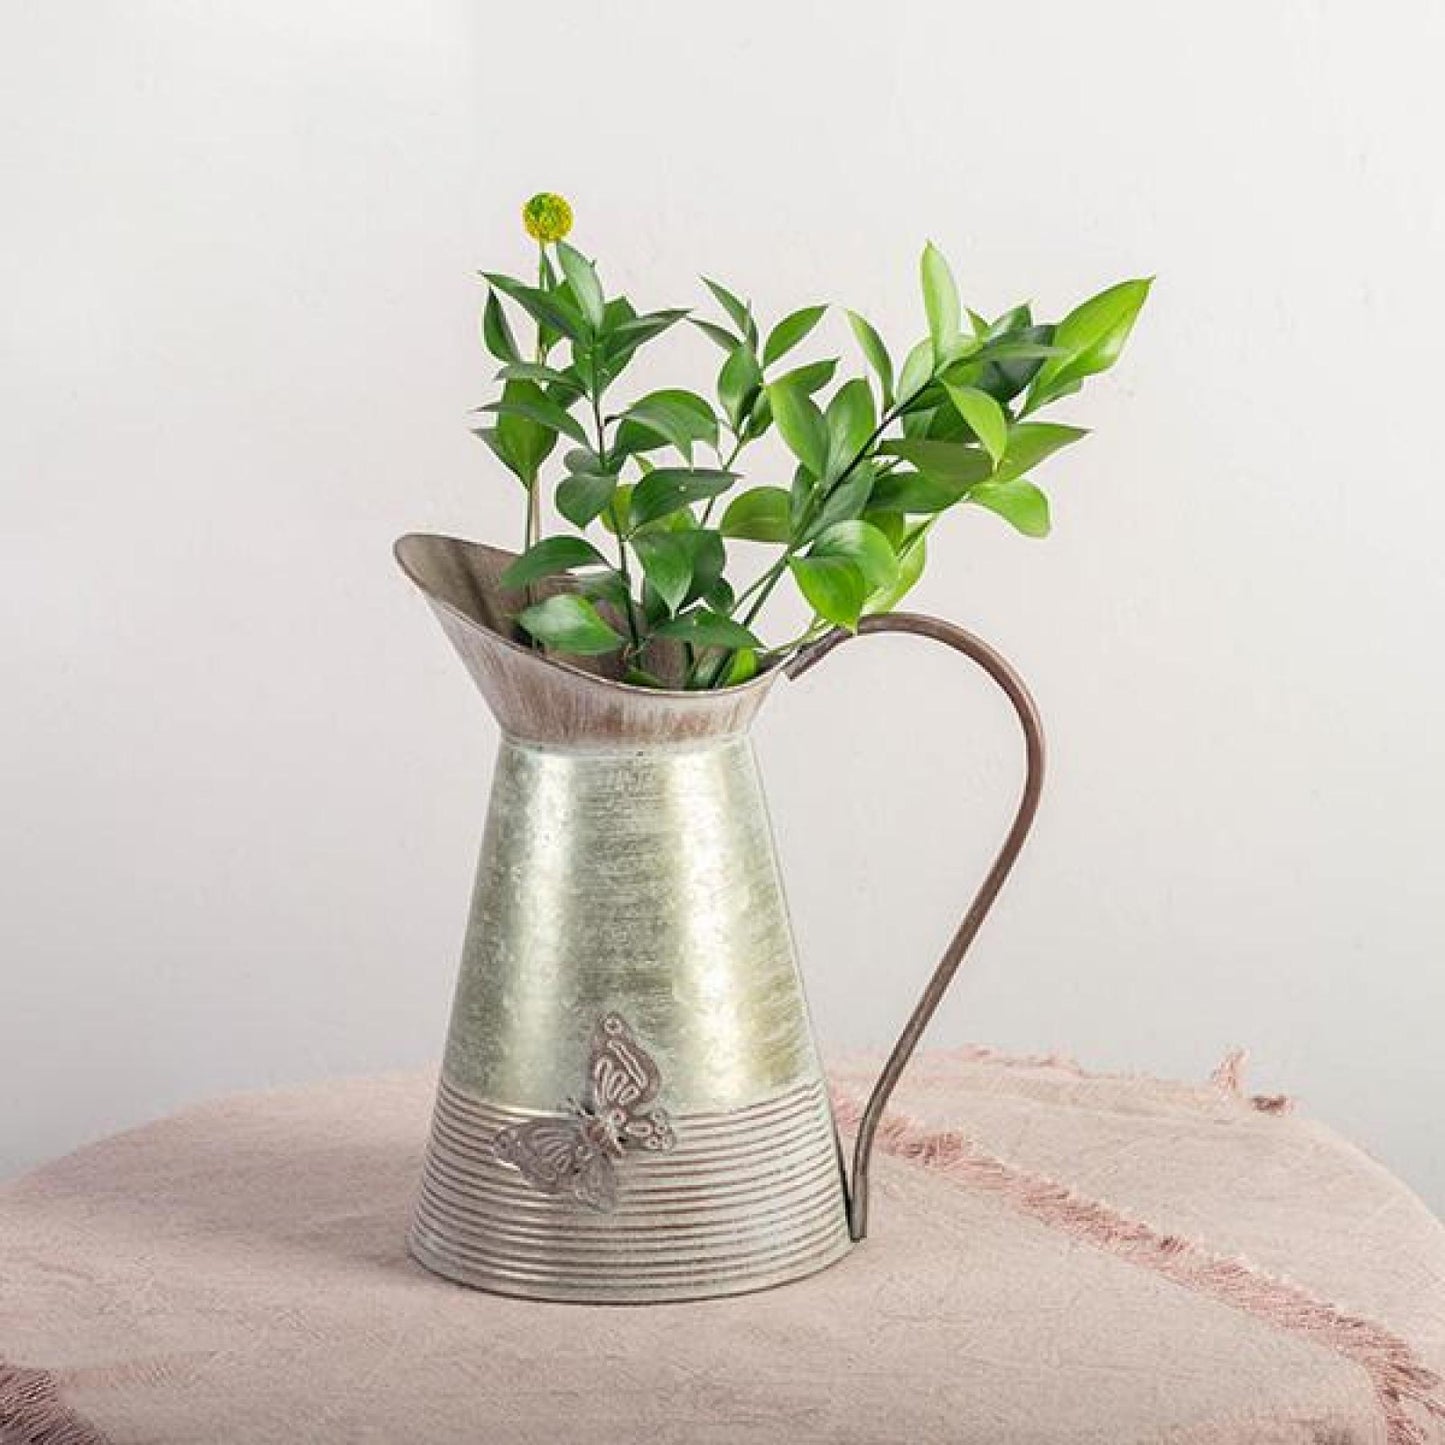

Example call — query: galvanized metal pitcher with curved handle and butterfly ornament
[396,535,1043,1302]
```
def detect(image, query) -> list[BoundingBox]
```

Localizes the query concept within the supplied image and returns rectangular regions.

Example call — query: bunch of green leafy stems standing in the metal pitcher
[475,197,1150,688]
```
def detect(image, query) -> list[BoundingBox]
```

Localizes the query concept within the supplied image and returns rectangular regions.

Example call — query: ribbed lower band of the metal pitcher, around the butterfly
[410,1079,850,1303]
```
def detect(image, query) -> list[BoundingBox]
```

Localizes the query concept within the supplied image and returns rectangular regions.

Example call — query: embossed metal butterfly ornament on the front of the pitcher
[491,1013,678,1211]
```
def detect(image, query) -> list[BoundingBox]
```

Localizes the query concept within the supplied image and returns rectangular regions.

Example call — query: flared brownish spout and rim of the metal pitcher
[394,532,777,747]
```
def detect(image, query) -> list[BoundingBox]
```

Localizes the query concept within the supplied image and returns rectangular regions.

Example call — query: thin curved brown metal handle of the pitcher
[785,613,1043,1240]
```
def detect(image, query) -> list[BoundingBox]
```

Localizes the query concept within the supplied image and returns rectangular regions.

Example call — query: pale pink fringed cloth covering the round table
[0,1051,1445,1445]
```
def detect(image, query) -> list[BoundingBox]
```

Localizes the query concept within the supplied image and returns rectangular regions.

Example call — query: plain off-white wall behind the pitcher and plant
[0,0,1445,1207]
